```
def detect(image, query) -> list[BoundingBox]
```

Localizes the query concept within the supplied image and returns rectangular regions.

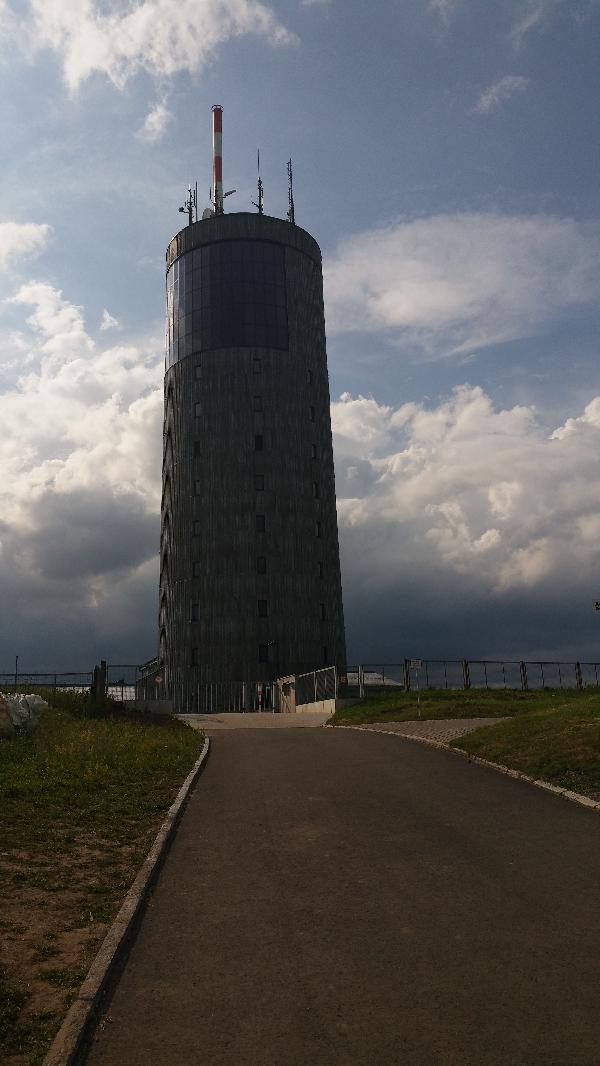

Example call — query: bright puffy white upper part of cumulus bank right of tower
[331,385,600,596]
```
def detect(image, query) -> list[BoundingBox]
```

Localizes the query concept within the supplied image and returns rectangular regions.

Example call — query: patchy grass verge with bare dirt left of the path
[0,692,204,1066]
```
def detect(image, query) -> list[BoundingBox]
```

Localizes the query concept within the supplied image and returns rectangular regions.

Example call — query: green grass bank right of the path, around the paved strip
[330,689,600,801]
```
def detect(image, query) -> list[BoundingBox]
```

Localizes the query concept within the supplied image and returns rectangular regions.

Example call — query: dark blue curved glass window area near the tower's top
[166,240,289,370]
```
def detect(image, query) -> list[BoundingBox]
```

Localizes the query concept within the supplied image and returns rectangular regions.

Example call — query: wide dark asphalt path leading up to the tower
[87,729,600,1066]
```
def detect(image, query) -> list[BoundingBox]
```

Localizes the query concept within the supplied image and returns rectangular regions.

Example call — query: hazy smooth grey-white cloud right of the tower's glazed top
[325,212,600,358]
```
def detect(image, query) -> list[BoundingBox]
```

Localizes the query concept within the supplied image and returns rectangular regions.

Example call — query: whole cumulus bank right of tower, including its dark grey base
[331,385,600,661]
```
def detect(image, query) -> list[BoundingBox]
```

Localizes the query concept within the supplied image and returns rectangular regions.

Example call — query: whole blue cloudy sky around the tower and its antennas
[0,0,600,672]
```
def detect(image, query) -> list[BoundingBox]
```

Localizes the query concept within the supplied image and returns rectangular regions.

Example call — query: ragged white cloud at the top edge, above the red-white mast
[28,0,295,92]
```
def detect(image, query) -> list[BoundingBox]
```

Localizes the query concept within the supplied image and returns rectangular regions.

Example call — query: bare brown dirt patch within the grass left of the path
[0,818,160,1066]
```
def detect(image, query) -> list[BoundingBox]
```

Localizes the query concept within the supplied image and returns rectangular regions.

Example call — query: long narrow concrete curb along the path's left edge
[44,737,210,1066]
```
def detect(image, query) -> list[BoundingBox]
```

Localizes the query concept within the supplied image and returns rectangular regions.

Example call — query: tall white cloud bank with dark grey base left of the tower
[0,281,163,668]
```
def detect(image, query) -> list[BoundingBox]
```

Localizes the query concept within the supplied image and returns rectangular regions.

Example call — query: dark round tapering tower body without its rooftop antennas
[159,213,345,695]
